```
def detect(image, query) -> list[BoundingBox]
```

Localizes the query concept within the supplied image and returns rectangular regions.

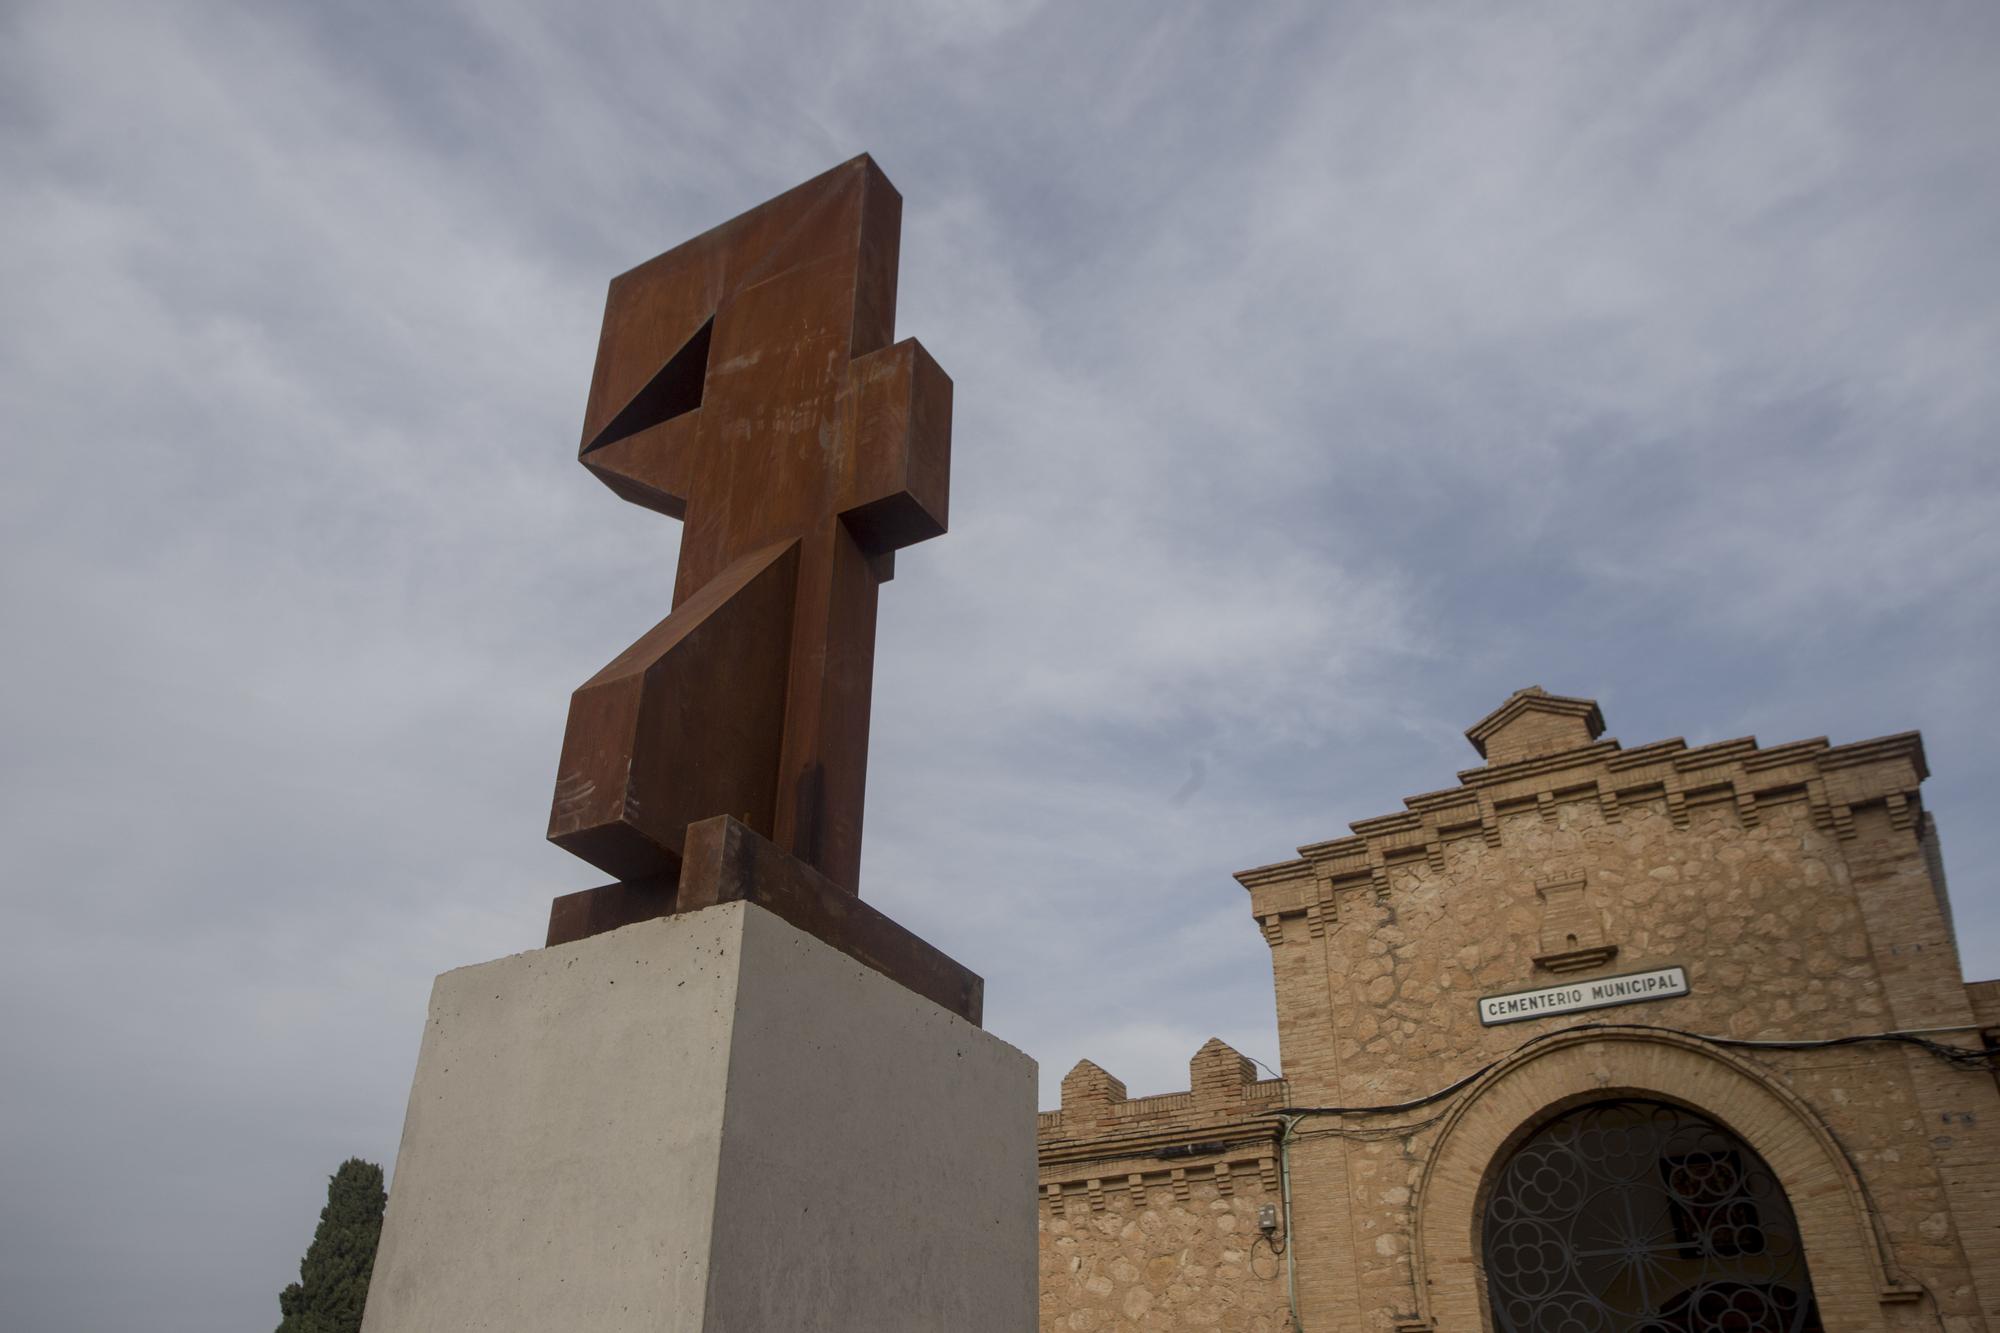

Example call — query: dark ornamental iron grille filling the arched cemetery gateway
[1484,1101,1824,1333]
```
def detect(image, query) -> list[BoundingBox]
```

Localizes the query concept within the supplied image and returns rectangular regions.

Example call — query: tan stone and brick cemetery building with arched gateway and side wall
[1038,689,2000,1333]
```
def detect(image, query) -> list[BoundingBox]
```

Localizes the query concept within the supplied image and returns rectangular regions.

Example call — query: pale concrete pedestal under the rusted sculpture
[362,903,1036,1333]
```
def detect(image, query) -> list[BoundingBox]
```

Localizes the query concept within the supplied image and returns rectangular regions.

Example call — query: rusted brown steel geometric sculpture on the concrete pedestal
[548,156,978,1021]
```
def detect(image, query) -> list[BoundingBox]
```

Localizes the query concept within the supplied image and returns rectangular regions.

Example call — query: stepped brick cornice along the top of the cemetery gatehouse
[1236,685,1930,932]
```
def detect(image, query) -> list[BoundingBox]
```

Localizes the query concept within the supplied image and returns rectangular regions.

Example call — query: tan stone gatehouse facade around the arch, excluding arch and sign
[1240,697,2000,1331]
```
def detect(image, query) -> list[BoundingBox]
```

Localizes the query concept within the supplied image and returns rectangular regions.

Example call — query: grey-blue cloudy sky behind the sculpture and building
[0,0,2000,1333]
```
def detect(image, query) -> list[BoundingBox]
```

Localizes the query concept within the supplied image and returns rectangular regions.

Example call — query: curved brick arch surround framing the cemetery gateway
[1412,1031,1916,1333]
